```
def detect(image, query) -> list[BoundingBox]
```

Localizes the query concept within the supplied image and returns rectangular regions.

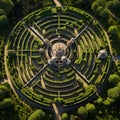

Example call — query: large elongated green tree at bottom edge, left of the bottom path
[28,109,45,120]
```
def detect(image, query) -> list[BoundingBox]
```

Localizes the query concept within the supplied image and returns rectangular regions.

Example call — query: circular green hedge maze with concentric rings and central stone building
[6,7,111,109]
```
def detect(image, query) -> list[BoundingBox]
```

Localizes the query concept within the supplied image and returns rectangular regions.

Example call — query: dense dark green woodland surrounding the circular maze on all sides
[0,0,120,120]
